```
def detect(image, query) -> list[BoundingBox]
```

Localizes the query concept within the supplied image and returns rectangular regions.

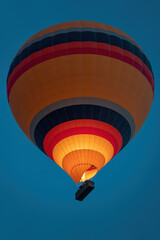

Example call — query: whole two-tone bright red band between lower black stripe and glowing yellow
[43,119,122,159]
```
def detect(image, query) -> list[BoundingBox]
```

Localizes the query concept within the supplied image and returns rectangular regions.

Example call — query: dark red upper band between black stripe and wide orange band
[7,42,154,98]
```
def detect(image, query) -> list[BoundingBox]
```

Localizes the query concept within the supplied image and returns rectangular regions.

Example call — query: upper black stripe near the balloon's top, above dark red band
[7,31,152,81]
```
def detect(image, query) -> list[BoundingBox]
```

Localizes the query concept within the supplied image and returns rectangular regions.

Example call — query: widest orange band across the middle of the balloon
[10,54,153,141]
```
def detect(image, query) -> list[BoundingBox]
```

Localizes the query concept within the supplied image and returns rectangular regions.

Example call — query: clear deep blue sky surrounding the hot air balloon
[0,0,160,240]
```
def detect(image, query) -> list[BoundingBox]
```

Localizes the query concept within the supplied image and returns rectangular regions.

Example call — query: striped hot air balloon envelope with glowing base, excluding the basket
[7,21,154,201]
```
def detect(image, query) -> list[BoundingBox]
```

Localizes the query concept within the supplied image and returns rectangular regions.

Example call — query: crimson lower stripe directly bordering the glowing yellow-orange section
[43,127,122,159]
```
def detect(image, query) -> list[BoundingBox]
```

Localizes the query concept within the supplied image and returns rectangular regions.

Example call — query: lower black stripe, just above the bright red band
[34,105,131,152]
